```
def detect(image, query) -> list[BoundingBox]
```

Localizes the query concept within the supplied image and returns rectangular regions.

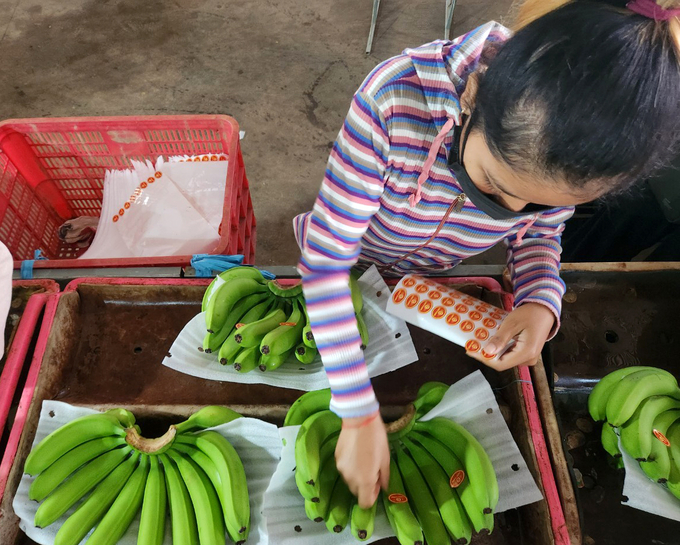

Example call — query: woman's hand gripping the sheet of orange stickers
[476,303,555,371]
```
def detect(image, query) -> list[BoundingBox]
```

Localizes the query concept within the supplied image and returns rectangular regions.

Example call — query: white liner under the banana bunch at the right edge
[620,423,680,522]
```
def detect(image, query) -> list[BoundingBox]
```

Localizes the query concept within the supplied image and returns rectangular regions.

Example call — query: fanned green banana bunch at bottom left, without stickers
[25,406,252,545]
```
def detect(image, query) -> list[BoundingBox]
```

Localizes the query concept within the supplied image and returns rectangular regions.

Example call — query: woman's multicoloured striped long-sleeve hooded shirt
[294,22,573,417]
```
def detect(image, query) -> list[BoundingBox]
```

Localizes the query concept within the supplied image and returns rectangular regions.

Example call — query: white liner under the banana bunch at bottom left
[12,401,281,545]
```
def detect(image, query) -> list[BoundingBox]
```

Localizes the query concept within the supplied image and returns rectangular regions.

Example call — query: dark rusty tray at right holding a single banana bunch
[534,263,680,545]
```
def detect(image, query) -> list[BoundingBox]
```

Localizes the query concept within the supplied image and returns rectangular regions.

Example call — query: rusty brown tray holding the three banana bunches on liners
[0,279,554,545]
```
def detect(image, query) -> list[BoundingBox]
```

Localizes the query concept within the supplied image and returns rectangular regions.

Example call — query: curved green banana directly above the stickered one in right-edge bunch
[624,396,680,462]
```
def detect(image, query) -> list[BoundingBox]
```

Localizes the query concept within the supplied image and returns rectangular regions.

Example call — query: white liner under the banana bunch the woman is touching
[264,371,543,545]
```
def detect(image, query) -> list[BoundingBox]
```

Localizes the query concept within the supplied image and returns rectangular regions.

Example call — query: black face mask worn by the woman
[448,113,554,220]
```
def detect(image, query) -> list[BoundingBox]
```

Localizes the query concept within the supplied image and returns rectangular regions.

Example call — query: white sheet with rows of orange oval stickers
[387,274,511,360]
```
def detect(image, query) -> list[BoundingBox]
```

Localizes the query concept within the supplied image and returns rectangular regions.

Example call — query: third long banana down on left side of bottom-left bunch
[34,446,132,528]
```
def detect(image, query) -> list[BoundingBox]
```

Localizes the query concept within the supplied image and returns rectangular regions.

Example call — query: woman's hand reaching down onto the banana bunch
[335,413,390,508]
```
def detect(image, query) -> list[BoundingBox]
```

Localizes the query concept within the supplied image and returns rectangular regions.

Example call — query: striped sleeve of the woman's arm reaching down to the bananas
[294,92,389,417]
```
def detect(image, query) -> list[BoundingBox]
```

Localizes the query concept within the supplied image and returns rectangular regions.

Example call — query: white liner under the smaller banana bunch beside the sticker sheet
[163,267,418,391]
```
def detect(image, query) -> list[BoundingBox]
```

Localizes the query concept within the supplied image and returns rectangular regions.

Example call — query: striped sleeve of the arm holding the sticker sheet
[507,208,574,337]
